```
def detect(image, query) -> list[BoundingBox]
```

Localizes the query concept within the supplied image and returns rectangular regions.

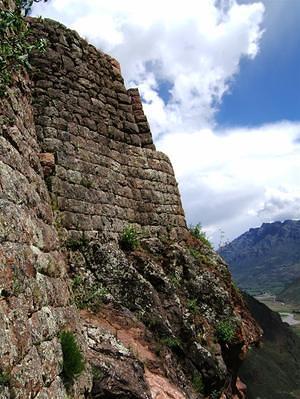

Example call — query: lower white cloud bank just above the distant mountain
[157,122,300,243]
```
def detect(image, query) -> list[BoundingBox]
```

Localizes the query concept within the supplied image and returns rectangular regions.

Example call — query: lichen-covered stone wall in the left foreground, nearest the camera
[0,2,89,399]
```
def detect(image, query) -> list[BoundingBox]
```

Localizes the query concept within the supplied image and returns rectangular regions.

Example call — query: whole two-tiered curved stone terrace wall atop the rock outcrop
[31,20,186,242]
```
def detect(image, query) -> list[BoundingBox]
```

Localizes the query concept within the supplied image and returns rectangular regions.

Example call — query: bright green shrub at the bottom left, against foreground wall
[60,331,84,387]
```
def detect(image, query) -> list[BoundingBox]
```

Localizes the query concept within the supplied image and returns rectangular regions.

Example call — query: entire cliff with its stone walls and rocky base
[0,7,260,399]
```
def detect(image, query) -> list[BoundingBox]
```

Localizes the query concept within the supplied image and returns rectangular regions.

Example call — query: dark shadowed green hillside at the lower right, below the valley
[240,294,300,399]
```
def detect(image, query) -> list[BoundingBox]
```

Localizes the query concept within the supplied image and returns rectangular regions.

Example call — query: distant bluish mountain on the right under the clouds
[218,220,300,293]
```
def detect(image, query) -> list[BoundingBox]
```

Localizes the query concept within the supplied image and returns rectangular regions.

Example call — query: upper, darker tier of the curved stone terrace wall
[30,19,155,149]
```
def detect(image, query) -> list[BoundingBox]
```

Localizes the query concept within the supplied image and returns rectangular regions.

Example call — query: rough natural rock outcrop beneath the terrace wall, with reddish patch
[70,239,259,399]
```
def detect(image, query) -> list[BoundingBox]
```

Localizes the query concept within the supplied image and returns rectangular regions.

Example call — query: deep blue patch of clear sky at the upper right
[216,0,300,126]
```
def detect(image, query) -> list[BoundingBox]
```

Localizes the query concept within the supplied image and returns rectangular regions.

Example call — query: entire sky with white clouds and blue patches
[33,0,300,247]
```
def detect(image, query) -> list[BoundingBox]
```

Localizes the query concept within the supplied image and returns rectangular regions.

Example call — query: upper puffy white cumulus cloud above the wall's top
[34,0,264,137]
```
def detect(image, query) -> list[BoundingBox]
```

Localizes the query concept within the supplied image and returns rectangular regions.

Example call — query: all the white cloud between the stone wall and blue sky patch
[34,0,300,243]
